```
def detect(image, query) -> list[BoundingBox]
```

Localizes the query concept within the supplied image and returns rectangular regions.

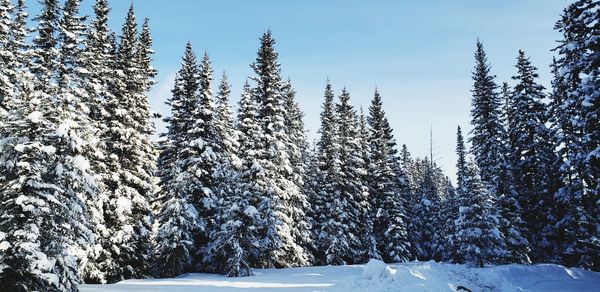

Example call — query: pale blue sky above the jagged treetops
[28,0,570,182]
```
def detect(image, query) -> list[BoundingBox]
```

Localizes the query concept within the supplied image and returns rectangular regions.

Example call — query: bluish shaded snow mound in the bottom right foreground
[336,260,600,292]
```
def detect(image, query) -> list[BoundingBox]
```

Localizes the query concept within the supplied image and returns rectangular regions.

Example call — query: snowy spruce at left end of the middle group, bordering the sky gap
[154,43,203,277]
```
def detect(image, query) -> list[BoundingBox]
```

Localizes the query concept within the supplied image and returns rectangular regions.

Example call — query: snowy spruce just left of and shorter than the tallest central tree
[206,82,264,277]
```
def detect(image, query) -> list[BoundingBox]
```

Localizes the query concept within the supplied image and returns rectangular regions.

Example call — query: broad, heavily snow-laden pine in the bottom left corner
[0,65,88,291]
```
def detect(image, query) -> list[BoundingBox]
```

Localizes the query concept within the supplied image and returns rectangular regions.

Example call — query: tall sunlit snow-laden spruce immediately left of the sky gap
[97,6,156,282]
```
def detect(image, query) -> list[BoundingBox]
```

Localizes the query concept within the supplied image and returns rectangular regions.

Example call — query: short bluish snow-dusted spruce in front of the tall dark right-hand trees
[453,161,506,267]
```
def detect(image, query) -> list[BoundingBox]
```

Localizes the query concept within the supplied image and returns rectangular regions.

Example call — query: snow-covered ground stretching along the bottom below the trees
[81,261,600,292]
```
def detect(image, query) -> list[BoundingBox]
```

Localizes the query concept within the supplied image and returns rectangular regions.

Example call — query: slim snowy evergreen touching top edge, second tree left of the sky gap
[78,0,116,283]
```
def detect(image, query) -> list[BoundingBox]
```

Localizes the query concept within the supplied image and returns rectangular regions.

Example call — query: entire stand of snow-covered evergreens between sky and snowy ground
[0,0,600,291]
